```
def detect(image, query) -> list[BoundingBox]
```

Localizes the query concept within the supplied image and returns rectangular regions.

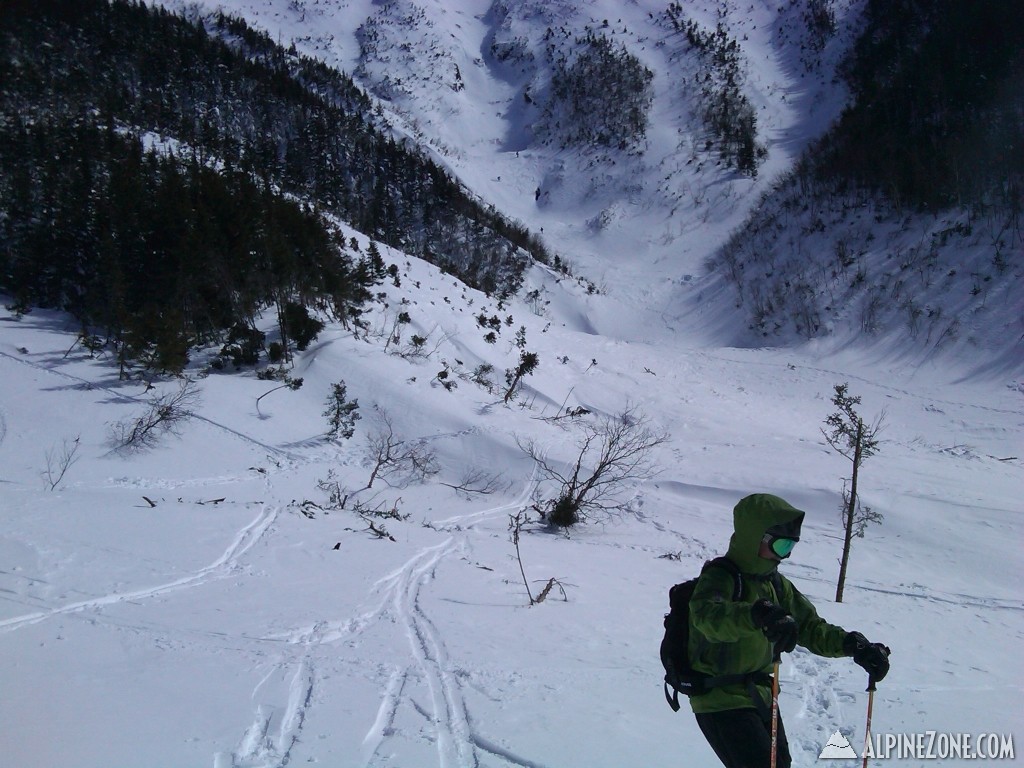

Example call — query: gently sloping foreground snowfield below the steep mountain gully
[0,225,1024,768]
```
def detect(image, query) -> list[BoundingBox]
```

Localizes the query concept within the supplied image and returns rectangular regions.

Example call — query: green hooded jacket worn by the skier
[689,494,846,713]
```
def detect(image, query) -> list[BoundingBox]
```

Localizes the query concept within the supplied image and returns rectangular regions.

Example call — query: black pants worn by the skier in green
[696,710,791,768]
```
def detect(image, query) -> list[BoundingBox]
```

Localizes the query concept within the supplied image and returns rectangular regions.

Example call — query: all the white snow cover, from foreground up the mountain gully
[0,0,1024,768]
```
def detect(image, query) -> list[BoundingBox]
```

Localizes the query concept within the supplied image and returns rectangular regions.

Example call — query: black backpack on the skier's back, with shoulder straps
[662,557,782,712]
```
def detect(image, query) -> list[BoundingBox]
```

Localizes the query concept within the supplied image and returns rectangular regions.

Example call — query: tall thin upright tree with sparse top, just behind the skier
[821,384,885,603]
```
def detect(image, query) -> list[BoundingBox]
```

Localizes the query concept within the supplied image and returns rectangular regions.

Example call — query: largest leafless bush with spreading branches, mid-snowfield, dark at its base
[517,407,669,527]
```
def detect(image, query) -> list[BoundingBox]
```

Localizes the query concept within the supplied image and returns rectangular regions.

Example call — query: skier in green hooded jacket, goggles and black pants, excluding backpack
[689,494,889,768]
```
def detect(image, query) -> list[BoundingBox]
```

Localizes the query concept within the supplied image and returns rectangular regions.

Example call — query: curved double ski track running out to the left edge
[0,506,281,633]
